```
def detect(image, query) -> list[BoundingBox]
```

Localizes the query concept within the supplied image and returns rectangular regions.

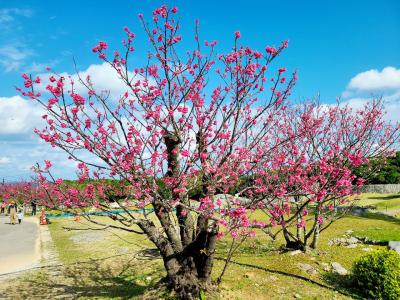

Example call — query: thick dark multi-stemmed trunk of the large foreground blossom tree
[152,134,218,300]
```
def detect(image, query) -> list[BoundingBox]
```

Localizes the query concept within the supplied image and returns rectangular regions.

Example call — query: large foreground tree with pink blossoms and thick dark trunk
[16,5,296,299]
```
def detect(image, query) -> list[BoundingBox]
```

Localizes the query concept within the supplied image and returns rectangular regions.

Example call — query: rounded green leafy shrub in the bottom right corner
[353,250,400,300]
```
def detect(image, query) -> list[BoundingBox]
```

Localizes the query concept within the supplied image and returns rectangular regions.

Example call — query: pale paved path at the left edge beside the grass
[0,216,41,275]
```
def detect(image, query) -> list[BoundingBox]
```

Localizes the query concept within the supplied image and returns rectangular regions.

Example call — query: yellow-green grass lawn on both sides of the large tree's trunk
[0,200,400,300]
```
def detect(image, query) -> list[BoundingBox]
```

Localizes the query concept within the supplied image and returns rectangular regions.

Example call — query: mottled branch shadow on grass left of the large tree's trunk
[0,252,163,299]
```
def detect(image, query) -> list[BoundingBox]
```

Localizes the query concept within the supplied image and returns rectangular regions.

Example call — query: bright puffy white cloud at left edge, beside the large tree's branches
[0,96,43,137]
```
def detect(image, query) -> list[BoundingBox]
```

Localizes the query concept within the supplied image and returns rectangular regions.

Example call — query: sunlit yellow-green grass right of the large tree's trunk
[215,210,400,299]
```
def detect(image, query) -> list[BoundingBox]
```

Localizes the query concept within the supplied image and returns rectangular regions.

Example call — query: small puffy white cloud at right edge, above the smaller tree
[347,67,400,92]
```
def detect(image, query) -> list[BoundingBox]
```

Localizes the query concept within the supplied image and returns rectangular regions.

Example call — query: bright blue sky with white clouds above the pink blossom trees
[0,0,400,180]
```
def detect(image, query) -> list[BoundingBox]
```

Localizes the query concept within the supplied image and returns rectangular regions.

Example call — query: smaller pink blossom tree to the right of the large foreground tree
[250,100,399,250]
